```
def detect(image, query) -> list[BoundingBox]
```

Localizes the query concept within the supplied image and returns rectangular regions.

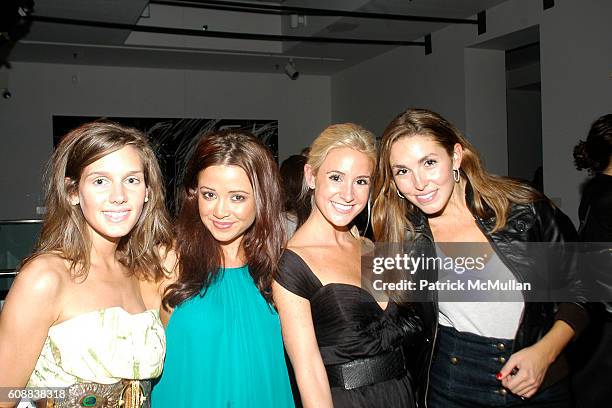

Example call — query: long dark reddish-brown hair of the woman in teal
[163,130,285,308]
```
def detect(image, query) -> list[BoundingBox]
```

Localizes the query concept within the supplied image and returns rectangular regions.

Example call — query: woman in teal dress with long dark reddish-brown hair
[152,131,294,408]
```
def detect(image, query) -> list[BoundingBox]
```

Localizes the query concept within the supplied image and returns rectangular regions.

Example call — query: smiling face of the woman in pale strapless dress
[70,146,147,242]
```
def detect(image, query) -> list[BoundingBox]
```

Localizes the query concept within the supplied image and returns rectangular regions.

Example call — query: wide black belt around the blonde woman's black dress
[325,348,407,390]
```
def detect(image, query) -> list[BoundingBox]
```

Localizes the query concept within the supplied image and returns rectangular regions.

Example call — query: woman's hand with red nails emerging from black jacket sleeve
[497,320,574,398]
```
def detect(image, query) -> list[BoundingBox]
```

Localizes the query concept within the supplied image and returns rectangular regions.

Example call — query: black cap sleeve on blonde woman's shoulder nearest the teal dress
[276,249,321,300]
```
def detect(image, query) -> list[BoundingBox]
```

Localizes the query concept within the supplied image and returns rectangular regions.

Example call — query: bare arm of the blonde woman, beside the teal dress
[272,282,333,408]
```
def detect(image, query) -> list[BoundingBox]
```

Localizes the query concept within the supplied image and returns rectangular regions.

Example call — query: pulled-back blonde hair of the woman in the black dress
[298,123,376,226]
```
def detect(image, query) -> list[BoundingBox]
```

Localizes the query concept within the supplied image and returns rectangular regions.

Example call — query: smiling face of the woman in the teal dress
[198,165,256,246]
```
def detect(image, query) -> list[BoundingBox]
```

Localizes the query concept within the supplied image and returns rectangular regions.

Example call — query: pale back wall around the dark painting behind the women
[0,63,331,219]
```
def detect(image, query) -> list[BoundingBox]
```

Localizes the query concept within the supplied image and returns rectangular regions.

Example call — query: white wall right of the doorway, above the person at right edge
[540,0,612,220]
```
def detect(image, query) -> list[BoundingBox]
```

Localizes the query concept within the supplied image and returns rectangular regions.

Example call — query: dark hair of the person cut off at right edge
[574,113,612,174]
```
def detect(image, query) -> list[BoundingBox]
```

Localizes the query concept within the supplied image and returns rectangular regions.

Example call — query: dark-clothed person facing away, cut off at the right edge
[573,114,612,408]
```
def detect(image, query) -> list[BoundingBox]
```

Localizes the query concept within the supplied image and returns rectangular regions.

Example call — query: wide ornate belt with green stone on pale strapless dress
[36,380,151,408]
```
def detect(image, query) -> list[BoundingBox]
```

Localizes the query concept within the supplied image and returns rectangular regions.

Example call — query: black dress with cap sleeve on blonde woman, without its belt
[277,250,422,408]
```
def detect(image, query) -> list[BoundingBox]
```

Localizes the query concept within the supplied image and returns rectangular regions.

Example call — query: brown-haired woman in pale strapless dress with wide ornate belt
[0,122,172,407]
